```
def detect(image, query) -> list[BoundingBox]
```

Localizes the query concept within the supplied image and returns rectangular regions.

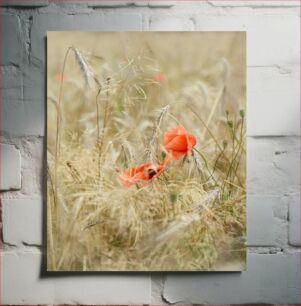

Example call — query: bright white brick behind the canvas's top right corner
[193,8,300,66]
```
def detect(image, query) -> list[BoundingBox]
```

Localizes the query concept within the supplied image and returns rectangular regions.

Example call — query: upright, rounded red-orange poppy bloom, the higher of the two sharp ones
[164,125,196,159]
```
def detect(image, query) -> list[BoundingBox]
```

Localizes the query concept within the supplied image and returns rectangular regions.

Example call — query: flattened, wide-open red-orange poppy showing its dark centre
[119,158,169,187]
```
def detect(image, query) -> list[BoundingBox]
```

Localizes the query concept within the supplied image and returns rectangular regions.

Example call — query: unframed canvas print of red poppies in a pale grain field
[47,32,247,272]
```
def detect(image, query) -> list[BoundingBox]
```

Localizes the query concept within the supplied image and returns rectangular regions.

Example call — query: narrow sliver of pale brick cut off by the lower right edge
[288,194,301,246]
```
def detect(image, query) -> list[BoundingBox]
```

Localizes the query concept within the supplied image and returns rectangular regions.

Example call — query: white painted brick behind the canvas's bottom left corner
[1,251,150,305]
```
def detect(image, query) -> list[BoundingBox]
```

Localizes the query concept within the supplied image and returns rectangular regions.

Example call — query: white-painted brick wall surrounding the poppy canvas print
[0,0,300,304]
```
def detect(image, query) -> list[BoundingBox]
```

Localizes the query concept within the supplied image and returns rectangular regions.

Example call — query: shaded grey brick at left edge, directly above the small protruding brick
[1,66,46,136]
